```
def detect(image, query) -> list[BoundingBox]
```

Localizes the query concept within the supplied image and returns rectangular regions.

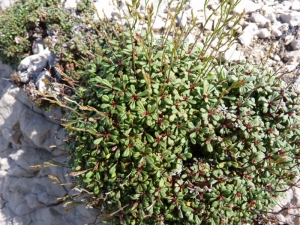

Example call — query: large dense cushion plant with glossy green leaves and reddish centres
[2,0,300,224]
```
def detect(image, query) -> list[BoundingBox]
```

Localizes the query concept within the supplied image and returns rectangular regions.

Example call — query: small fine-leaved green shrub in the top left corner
[0,0,79,68]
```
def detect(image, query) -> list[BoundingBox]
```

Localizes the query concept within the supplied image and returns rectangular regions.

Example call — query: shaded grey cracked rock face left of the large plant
[0,60,103,225]
